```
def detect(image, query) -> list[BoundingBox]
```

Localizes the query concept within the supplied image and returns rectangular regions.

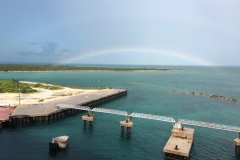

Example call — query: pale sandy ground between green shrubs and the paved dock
[0,81,96,106]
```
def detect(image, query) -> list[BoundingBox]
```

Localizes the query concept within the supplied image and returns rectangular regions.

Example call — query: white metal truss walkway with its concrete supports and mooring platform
[56,104,240,159]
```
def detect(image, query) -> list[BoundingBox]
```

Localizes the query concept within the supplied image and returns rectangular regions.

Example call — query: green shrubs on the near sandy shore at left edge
[0,79,37,93]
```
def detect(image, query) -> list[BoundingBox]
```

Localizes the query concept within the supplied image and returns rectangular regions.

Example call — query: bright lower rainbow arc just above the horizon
[57,48,216,66]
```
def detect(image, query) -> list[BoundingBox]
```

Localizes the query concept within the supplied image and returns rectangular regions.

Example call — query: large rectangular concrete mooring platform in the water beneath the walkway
[163,124,194,160]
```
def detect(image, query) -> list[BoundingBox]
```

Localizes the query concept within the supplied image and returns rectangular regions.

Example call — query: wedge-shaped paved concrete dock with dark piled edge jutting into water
[7,89,127,125]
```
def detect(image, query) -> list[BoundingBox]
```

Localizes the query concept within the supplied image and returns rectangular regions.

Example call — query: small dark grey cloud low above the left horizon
[19,42,58,56]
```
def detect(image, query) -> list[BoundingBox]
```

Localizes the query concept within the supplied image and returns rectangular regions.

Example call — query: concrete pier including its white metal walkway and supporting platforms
[0,89,240,160]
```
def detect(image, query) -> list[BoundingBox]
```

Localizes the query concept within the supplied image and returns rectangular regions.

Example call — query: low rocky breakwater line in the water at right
[173,91,240,103]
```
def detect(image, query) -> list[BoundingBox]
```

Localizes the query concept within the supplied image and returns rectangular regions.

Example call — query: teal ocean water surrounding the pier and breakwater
[0,66,240,160]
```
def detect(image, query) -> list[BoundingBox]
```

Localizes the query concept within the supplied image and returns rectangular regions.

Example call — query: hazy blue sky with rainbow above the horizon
[0,0,240,66]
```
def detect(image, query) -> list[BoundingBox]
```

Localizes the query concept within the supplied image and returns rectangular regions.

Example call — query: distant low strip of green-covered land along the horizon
[0,64,172,72]
